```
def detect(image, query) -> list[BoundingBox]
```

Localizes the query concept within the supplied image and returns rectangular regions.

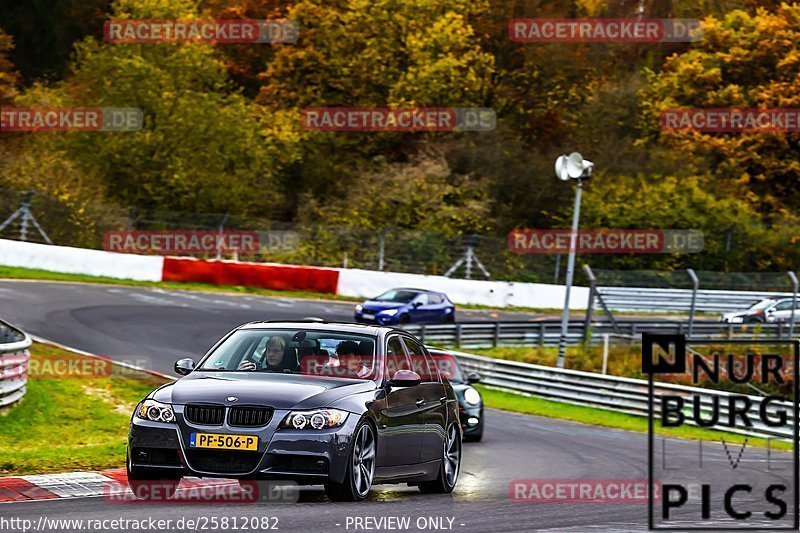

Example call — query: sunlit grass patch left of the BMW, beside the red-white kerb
[0,343,165,476]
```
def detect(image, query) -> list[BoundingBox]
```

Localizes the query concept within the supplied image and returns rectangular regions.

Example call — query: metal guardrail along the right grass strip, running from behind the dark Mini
[451,352,796,438]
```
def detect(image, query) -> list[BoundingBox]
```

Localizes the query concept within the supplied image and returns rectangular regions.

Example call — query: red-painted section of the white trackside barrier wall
[163,257,339,294]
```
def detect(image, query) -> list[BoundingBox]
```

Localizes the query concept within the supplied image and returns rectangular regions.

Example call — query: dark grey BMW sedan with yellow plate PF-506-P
[127,322,462,501]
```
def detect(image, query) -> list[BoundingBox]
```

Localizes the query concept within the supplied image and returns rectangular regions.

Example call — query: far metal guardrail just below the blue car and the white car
[410,320,790,348]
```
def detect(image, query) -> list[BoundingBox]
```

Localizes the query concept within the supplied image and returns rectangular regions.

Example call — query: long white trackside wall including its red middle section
[0,239,589,310]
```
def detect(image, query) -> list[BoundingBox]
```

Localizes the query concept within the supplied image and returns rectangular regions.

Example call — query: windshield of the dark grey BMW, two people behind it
[198,329,376,379]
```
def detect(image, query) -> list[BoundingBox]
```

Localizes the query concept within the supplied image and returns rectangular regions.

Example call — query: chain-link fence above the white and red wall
[0,190,566,283]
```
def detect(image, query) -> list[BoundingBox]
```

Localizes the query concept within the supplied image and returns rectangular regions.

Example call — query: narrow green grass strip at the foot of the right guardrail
[477,385,792,451]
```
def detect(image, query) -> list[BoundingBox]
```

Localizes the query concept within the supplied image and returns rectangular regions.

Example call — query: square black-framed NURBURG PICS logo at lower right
[642,333,800,531]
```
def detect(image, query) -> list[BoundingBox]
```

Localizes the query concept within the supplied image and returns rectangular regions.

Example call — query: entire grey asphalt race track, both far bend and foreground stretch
[0,276,791,533]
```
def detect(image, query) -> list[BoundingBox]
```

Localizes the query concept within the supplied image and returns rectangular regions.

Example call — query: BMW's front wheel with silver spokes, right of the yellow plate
[325,420,377,502]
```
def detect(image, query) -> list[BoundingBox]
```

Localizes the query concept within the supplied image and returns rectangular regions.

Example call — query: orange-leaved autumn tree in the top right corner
[642,4,800,212]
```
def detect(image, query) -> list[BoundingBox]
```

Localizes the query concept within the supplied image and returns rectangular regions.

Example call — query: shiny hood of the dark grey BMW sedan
[153,372,376,409]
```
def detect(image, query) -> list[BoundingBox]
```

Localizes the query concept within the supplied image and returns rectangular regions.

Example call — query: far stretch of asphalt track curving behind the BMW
[0,281,540,374]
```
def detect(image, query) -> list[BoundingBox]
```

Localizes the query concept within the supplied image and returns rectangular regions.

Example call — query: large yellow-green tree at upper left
[2,0,280,214]
